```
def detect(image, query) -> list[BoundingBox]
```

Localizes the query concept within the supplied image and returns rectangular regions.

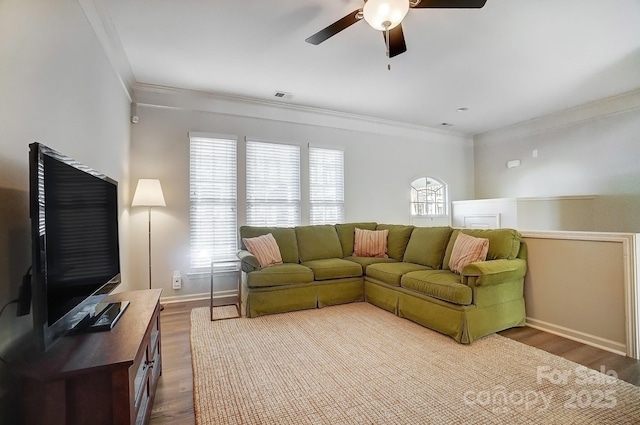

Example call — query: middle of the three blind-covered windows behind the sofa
[246,140,300,227]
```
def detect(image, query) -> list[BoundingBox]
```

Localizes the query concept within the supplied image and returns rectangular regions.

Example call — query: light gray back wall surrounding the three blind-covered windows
[130,88,473,300]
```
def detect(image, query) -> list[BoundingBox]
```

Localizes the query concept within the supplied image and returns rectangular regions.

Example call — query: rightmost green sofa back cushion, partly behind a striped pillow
[443,229,522,270]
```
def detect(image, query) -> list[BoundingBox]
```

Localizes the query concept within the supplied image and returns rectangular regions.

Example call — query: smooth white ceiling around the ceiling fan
[102,0,640,134]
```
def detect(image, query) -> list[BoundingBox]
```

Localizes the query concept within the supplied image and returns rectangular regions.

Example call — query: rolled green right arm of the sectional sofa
[461,258,527,287]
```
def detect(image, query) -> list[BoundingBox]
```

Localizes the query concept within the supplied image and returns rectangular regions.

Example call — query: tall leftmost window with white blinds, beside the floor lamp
[189,137,238,271]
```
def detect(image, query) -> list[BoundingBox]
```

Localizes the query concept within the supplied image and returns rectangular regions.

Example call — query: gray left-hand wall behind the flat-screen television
[0,0,130,423]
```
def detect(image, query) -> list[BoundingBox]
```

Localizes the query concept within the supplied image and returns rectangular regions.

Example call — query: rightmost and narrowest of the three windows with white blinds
[309,146,344,224]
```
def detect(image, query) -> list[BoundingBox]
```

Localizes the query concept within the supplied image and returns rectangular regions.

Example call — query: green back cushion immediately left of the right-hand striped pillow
[403,226,453,269]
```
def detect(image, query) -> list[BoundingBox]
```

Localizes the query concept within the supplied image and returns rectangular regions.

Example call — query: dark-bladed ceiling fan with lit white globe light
[305,0,487,58]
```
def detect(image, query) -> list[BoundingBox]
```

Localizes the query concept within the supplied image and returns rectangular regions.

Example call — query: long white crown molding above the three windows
[133,83,472,145]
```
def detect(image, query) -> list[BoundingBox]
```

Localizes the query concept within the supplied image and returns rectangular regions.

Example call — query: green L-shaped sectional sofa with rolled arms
[238,222,527,344]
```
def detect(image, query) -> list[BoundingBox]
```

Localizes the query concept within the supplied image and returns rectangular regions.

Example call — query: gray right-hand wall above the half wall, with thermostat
[474,91,640,232]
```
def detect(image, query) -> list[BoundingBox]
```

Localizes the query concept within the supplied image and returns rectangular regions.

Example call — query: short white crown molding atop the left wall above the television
[78,0,136,101]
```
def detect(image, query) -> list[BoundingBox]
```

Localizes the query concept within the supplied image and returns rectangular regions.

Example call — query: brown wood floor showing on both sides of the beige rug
[150,300,640,425]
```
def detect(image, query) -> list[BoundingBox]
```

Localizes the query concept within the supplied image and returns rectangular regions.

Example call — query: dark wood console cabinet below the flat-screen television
[20,289,162,425]
